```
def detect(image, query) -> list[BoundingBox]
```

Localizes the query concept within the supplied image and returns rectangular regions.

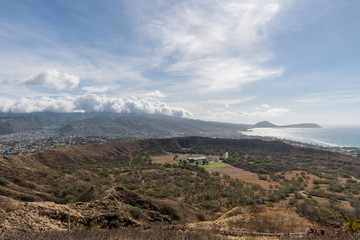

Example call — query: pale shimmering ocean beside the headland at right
[241,126,360,148]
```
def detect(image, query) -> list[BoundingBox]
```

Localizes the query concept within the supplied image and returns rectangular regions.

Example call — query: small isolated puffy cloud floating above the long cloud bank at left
[23,69,80,90]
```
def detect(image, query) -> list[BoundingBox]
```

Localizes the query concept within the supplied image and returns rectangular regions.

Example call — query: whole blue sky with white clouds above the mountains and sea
[0,0,360,125]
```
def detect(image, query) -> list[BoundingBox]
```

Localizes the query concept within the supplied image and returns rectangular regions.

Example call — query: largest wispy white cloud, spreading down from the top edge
[149,0,282,91]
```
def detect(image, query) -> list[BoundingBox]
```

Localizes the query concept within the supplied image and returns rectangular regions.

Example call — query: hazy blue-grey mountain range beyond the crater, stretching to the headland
[0,112,320,138]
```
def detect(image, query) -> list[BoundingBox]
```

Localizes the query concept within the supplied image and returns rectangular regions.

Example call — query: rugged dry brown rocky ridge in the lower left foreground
[0,187,195,231]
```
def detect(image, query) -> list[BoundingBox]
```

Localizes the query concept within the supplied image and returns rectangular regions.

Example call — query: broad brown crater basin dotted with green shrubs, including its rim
[0,137,360,236]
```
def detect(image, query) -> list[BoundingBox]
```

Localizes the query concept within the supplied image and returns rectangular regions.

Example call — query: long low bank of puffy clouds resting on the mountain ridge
[0,94,192,117]
